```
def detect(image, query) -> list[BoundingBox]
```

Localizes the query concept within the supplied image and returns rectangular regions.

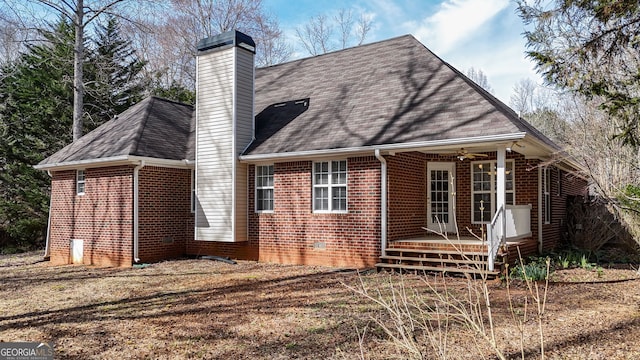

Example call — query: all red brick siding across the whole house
[50,152,586,267]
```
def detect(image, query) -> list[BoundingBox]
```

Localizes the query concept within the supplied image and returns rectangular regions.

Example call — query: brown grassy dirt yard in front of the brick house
[0,253,640,359]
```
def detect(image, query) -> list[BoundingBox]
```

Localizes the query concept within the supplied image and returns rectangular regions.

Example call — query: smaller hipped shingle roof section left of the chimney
[39,96,193,165]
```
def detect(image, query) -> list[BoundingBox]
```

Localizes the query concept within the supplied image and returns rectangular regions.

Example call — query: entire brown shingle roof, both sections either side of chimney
[39,35,558,165]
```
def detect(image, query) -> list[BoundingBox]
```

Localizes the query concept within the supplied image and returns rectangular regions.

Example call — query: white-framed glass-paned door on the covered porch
[427,162,456,232]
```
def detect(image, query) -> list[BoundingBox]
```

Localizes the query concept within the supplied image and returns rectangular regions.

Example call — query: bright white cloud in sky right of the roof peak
[405,0,509,55]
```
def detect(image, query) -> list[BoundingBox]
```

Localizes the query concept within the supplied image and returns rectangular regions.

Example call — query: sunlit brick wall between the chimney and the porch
[187,156,380,267]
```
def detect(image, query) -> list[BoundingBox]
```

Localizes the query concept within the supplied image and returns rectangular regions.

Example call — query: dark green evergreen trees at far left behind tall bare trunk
[0,19,149,250]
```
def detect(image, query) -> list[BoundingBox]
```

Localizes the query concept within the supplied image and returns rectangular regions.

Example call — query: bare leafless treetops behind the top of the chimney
[130,0,291,93]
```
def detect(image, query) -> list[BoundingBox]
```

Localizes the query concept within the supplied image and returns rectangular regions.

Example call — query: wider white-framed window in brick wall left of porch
[313,160,347,213]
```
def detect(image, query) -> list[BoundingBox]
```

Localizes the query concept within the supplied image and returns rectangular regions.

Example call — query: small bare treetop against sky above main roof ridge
[296,9,372,56]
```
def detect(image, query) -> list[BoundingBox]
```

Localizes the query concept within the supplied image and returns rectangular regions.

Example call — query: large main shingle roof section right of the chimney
[247,35,553,155]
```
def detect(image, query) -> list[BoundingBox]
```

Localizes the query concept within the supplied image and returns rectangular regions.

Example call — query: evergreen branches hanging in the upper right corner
[518,0,640,146]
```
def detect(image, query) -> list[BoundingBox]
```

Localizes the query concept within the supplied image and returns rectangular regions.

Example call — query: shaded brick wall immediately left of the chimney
[138,166,194,262]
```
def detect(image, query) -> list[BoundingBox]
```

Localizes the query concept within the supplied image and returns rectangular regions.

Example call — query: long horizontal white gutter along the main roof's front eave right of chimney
[240,132,526,162]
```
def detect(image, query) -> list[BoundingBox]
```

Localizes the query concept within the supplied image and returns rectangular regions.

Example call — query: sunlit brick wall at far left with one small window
[50,166,133,266]
